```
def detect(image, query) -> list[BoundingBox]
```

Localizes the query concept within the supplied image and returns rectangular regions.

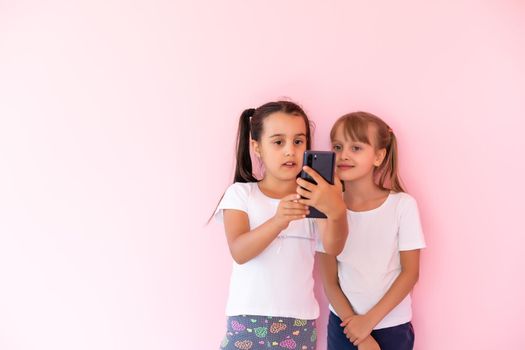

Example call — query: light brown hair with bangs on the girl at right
[330,112,405,192]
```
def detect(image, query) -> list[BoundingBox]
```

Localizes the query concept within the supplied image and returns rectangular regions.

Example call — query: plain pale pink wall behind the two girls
[0,0,525,350]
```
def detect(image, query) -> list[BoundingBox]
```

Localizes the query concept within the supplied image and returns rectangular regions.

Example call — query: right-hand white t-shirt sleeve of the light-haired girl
[399,196,426,251]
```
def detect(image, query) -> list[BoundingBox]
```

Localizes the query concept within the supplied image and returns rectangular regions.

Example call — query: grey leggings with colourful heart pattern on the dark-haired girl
[220,315,317,350]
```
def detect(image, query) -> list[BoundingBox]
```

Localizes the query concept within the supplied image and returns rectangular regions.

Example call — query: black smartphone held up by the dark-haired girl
[300,151,335,219]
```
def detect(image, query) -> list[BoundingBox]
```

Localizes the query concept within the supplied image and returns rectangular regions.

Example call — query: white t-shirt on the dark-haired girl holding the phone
[215,182,319,320]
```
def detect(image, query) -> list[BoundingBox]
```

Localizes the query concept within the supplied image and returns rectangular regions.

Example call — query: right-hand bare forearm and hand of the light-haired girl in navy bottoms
[343,249,420,345]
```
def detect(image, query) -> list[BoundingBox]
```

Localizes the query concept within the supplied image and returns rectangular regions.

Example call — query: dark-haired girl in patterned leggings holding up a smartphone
[215,101,348,350]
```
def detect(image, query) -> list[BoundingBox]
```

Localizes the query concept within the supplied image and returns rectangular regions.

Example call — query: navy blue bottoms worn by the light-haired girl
[327,312,414,350]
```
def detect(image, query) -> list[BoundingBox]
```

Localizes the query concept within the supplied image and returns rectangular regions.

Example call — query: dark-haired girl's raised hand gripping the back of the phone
[297,166,346,218]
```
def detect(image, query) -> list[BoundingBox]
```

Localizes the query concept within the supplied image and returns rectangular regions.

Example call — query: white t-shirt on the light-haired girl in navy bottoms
[318,193,425,329]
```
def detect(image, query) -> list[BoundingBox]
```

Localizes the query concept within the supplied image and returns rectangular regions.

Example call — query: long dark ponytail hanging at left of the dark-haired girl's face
[233,108,257,182]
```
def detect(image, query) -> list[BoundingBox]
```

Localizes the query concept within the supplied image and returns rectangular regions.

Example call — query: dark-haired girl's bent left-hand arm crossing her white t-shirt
[223,194,307,264]
